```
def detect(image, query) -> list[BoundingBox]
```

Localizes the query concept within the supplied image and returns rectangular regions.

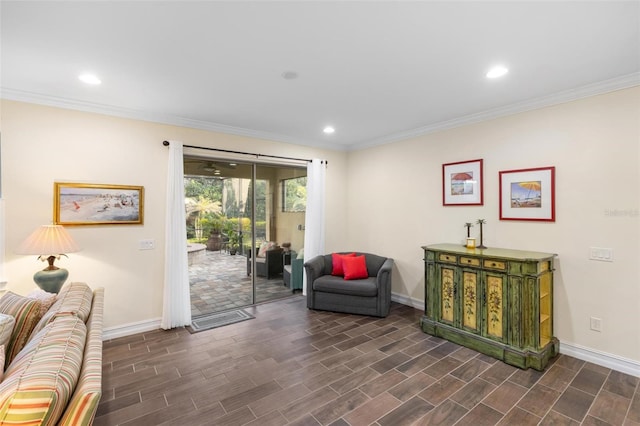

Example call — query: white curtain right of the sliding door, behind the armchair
[302,159,327,294]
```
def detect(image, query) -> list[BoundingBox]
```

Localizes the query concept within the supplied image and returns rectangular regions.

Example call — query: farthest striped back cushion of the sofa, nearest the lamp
[32,282,93,336]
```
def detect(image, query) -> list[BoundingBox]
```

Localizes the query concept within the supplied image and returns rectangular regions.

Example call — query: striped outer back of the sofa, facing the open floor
[59,288,104,426]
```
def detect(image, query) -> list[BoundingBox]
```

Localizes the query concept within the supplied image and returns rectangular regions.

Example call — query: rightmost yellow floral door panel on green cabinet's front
[482,272,508,342]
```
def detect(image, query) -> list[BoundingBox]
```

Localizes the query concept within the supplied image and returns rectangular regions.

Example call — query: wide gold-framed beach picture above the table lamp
[53,182,144,226]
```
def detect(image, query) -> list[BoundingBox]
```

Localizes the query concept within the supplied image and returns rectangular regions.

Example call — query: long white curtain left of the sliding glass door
[160,141,191,330]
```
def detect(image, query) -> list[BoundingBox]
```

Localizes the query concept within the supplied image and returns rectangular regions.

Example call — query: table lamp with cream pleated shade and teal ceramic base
[16,225,80,293]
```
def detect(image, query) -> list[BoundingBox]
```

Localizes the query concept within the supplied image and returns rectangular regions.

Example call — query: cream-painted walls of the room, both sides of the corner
[0,87,640,372]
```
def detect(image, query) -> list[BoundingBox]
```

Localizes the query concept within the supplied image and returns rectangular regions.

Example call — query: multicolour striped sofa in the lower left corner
[0,283,104,426]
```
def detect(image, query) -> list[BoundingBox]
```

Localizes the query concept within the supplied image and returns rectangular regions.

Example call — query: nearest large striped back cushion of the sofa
[0,315,87,425]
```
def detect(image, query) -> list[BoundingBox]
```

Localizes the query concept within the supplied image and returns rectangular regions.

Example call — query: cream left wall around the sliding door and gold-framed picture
[0,100,346,329]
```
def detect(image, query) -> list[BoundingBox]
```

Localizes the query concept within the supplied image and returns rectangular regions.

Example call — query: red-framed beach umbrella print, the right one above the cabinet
[499,167,556,222]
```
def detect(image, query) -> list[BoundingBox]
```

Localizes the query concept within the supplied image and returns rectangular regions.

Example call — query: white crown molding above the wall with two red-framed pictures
[349,72,640,151]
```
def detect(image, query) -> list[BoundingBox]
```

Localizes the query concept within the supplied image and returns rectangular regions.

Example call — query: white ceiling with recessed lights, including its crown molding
[0,0,640,150]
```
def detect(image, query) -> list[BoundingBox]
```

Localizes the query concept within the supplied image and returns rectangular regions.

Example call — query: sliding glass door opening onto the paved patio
[184,157,306,318]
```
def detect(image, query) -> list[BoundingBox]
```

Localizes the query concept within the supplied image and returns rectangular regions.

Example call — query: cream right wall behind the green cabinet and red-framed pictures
[347,87,640,365]
